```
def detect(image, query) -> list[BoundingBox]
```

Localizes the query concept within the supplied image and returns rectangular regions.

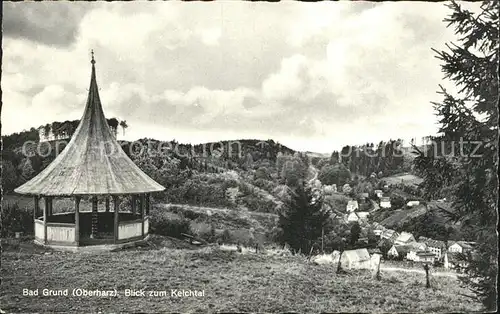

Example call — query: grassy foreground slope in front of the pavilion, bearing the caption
[0,237,481,313]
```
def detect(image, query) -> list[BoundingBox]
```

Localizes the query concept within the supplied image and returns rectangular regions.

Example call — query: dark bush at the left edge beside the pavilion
[1,203,34,237]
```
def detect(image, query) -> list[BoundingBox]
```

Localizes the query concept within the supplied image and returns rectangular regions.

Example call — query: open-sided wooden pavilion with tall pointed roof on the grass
[15,52,165,247]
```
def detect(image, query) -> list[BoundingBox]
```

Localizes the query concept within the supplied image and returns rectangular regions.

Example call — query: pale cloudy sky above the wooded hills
[2,1,480,152]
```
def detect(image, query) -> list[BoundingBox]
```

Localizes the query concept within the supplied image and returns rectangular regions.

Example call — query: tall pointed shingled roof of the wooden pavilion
[14,53,165,196]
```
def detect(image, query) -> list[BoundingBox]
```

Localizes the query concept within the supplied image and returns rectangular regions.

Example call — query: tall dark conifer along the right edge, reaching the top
[415,0,499,311]
